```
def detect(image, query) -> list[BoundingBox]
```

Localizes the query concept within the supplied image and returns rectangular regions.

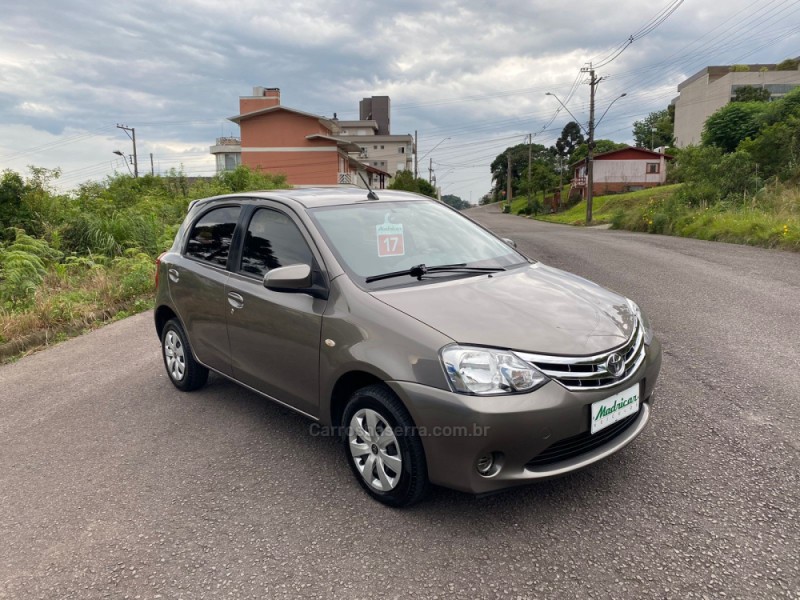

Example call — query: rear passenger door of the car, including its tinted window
[167,204,242,375]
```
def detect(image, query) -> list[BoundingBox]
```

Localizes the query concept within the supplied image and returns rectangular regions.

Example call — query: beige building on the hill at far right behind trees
[672,65,800,148]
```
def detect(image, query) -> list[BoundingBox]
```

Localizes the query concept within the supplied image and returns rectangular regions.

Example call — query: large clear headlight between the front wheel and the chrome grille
[441,345,548,396]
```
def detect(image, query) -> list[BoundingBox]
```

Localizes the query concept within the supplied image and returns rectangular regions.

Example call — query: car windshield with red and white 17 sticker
[309,200,528,287]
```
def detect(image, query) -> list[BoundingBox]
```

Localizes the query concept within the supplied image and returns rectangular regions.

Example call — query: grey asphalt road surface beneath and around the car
[0,207,800,599]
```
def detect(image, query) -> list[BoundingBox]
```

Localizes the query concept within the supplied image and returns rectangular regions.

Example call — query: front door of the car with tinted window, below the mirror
[226,203,326,416]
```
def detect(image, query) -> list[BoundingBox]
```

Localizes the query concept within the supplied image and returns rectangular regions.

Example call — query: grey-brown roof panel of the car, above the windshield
[191,186,433,208]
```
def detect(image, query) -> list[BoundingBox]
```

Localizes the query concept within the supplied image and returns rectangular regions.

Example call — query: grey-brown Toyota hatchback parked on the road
[155,188,661,506]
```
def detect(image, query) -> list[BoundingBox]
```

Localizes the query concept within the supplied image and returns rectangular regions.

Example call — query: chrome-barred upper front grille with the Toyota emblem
[516,321,645,390]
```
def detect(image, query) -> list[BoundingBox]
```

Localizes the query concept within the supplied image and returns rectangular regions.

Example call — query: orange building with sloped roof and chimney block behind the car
[216,87,389,189]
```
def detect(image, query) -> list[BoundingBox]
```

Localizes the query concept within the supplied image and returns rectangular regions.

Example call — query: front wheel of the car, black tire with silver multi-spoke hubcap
[342,384,430,507]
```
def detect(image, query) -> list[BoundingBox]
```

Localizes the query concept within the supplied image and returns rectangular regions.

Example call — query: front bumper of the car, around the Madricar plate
[389,339,661,494]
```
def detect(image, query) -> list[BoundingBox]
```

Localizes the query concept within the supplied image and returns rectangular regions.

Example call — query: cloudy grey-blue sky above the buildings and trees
[0,0,800,202]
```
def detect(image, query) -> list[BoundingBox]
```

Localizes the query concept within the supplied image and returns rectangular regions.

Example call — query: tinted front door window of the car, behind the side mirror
[240,208,313,278]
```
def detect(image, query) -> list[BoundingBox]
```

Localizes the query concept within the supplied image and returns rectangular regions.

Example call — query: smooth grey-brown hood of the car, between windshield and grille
[372,263,636,356]
